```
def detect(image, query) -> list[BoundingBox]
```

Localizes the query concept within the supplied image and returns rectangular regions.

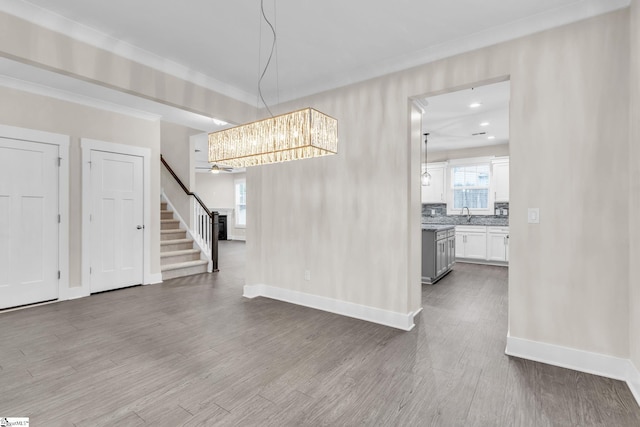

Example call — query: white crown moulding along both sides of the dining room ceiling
[0,0,630,105]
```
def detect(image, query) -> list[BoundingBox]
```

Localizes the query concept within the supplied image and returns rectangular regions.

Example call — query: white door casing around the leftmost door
[0,124,70,301]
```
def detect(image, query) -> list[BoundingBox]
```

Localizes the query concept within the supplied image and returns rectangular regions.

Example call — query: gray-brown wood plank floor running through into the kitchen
[0,242,640,426]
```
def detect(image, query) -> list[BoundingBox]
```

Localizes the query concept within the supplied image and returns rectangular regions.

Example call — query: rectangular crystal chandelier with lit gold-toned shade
[209,108,338,168]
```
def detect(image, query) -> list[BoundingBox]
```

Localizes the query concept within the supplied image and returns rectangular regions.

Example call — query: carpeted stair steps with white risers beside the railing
[160,202,209,280]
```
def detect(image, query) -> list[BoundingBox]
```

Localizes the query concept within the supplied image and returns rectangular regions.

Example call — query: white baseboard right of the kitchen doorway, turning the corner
[505,335,640,405]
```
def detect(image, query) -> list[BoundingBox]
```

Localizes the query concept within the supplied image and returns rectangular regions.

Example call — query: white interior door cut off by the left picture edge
[0,138,59,308]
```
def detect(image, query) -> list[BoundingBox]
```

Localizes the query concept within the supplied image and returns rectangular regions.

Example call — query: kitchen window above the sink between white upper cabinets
[450,163,491,214]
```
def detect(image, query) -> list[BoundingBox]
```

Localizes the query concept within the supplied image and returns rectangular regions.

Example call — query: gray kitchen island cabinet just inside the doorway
[422,224,456,284]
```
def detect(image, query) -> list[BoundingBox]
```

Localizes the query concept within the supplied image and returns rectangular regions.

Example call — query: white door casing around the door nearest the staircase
[80,138,156,294]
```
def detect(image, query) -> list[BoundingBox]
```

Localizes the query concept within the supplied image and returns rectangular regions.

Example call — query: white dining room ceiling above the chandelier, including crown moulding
[0,0,630,104]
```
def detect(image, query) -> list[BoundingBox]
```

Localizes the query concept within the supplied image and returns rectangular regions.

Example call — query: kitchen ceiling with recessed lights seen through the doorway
[418,81,510,152]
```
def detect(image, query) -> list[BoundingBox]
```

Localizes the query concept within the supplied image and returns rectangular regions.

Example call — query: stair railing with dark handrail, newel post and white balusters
[160,154,219,271]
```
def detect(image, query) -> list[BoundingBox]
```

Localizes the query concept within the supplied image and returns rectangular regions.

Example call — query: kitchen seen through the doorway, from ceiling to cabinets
[418,81,509,284]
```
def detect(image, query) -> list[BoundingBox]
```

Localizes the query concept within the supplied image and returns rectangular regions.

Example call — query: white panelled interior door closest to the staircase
[90,150,144,293]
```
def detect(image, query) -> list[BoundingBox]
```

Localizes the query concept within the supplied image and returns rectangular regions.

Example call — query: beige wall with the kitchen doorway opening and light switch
[247,10,629,357]
